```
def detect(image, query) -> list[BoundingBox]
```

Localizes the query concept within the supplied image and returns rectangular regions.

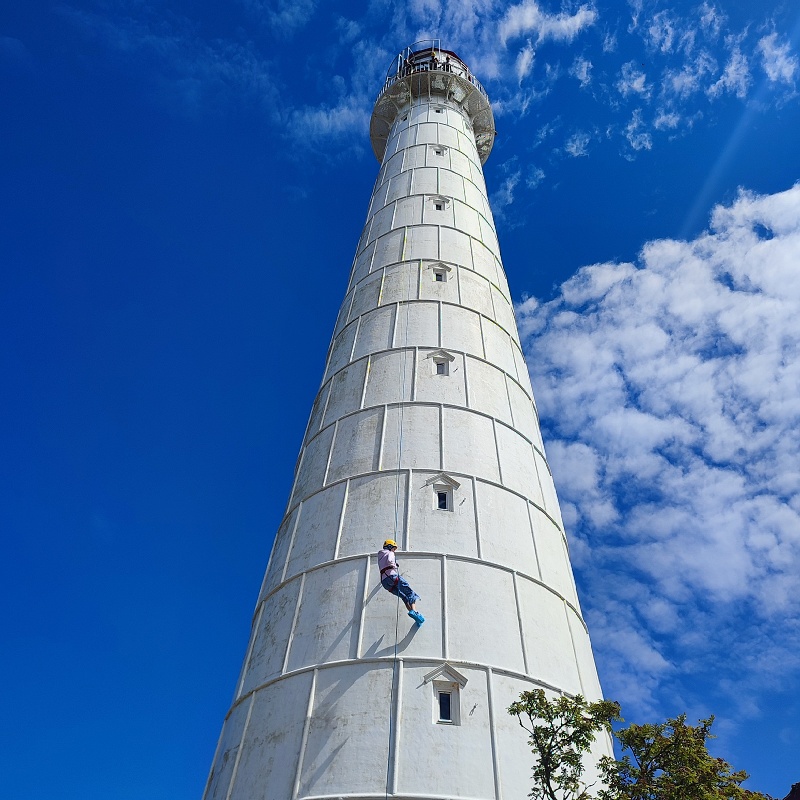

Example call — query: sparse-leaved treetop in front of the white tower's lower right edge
[508,689,621,800]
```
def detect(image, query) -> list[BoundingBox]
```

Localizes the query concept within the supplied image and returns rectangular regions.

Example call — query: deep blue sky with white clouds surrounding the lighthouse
[0,0,800,800]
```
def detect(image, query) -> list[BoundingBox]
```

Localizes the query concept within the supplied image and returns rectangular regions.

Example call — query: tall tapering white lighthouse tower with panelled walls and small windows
[205,41,610,800]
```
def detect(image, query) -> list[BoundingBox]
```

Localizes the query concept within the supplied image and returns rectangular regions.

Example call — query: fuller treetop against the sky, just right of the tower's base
[598,714,770,800]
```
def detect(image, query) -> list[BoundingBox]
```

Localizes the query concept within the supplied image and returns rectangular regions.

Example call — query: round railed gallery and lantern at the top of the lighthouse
[369,39,496,164]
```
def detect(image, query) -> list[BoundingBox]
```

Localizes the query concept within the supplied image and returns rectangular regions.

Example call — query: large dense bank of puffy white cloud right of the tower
[517,185,800,711]
